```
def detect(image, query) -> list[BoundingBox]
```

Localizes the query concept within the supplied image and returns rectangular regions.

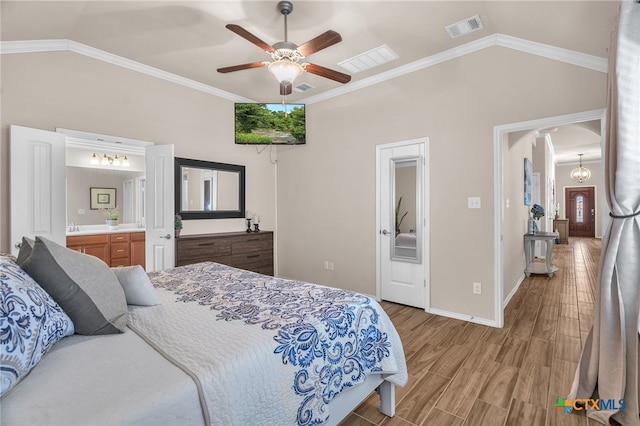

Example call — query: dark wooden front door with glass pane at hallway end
[564,186,596,238]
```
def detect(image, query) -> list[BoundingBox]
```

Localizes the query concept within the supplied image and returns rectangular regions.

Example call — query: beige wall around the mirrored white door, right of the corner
[278,47,606,319]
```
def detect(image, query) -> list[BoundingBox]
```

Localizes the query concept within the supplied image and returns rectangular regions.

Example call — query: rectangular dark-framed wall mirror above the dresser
[174,157,245,220]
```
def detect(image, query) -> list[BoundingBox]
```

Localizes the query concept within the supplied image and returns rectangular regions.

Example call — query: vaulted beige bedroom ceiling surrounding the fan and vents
[0,0,619,103]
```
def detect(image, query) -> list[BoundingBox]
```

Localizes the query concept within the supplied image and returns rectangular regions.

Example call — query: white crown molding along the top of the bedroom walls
[0,34,608,104]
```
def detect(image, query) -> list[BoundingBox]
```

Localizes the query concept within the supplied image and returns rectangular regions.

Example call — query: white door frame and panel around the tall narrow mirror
[376,138,429,309]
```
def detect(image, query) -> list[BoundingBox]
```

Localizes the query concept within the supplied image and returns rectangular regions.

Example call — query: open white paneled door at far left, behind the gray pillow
[10,125,67,255]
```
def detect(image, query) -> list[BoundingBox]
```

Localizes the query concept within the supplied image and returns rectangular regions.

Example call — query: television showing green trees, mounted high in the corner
[234,103,307,145]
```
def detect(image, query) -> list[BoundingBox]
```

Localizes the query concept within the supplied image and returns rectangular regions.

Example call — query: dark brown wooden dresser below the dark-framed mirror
[176,231,273,275]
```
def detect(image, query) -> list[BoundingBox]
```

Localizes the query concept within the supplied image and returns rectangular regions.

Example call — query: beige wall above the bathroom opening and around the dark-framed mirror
[0,52,276,251]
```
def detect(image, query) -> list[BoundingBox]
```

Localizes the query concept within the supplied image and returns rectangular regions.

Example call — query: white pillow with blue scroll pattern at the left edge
[0,256,74,396]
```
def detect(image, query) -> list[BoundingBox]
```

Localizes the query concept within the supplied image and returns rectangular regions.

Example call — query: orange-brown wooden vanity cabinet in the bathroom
[67,232,145,268]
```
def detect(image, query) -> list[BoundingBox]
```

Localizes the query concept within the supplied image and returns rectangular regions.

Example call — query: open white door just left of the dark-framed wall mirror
[144,145,175,271]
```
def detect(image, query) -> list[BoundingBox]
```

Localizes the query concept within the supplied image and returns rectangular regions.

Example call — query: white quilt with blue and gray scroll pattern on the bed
[129,262,407,425]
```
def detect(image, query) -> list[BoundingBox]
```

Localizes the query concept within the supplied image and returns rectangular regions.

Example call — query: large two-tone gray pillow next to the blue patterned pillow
[22,237,127,335]
